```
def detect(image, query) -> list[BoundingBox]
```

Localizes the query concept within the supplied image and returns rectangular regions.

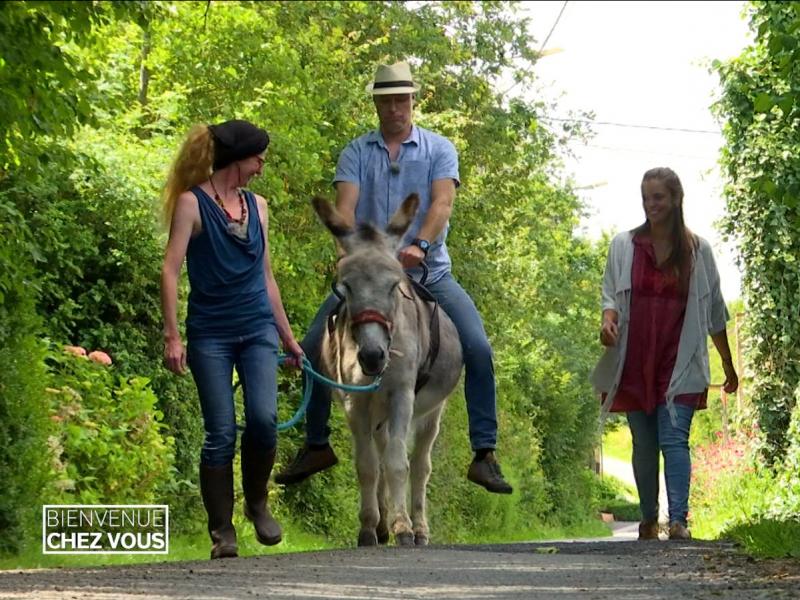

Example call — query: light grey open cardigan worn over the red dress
[591,231,730,420]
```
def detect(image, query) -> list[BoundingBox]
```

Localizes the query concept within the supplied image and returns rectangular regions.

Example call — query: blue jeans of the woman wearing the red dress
[627,403,694,525]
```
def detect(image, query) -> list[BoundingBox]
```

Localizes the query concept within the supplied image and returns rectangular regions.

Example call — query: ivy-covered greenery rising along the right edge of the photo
[715,2,800,454]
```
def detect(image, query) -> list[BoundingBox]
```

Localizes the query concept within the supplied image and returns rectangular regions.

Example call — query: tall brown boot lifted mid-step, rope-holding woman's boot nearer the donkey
[242,441,282,546]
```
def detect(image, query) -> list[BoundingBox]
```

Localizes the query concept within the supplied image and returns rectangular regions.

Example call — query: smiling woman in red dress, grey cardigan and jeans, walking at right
[592,168,738,539]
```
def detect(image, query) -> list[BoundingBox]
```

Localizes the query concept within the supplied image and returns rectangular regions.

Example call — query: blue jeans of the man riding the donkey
[300,273,497,450]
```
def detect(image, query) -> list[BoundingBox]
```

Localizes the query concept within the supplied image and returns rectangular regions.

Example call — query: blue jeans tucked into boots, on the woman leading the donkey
[187,325,278,467]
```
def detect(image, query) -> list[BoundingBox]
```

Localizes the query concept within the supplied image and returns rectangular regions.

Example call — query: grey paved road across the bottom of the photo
[0,540,800,600]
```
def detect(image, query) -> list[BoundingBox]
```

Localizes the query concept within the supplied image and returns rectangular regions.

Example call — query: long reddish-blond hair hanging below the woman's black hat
[161,125,214,228]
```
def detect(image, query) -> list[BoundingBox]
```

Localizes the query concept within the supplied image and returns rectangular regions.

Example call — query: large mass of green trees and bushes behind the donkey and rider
[0,1,601,552]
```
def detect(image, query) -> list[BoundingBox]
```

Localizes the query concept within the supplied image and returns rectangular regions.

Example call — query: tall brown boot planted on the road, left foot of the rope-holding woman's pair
[200,463,239,559]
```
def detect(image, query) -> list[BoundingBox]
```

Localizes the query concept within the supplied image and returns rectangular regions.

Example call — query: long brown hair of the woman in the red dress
[633,167,697,289]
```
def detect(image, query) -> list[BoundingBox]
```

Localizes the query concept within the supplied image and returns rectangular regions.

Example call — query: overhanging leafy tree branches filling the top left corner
[0,0,149,170]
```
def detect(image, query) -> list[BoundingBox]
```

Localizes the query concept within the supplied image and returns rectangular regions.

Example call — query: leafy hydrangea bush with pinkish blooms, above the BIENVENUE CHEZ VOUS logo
[47,348,174,504]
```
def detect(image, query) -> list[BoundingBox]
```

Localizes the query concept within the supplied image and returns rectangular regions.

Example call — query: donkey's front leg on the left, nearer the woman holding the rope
[348,406,380,546]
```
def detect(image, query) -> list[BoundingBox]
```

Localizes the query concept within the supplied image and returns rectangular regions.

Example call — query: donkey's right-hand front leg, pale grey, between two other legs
[384,389,414,546]
